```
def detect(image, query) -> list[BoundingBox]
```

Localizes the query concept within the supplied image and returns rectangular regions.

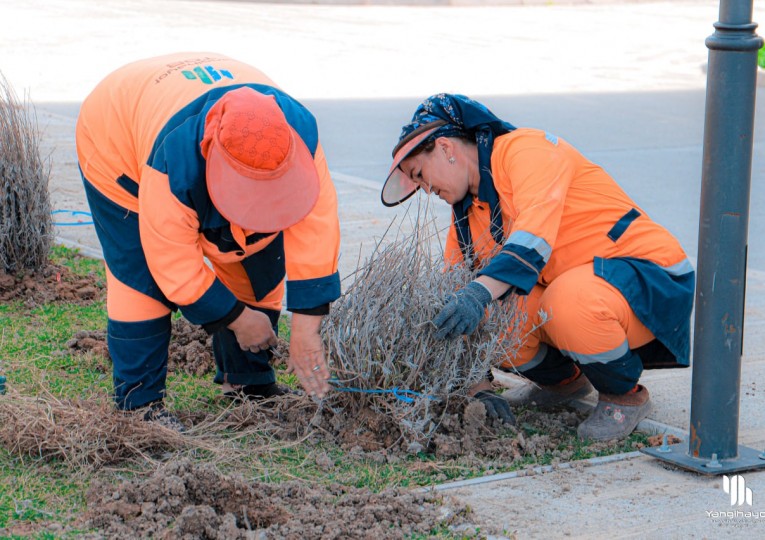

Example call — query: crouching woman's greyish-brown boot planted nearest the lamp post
[577,384,653,441]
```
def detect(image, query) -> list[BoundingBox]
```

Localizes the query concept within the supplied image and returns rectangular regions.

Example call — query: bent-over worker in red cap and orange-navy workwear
[77,53,340,428]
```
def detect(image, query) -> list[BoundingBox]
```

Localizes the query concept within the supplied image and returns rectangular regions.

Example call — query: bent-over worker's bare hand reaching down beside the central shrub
[287,313,330,398]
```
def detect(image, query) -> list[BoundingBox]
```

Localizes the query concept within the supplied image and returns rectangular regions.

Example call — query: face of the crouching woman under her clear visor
[400,141,468,204]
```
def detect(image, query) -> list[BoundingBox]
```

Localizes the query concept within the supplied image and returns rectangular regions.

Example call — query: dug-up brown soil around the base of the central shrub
[209,394,613,470]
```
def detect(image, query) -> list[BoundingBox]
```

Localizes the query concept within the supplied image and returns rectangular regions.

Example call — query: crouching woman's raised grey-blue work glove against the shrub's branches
[433,281,492,339]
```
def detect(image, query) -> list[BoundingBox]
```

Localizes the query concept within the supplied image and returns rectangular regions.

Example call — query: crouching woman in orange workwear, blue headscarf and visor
[382,94,694,440]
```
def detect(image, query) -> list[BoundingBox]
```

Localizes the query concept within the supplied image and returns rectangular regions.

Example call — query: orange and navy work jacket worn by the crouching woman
[446,128,694,364]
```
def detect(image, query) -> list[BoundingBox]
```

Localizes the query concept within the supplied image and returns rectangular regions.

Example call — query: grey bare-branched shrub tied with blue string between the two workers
[323,205,525,441]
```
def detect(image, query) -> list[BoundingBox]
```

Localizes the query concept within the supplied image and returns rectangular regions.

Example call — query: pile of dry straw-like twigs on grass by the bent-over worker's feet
[0,380,326,470]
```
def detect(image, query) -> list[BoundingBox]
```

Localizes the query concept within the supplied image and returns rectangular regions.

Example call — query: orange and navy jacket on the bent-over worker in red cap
[76,53,340,324]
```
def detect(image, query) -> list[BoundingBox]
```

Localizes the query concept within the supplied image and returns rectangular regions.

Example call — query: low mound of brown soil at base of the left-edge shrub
[0,264,104,307]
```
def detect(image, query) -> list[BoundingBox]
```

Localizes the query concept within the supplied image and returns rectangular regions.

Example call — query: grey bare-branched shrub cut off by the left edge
[0,74,53,273]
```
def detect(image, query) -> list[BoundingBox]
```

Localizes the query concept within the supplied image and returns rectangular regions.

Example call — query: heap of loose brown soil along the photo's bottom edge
[86,460,469,539]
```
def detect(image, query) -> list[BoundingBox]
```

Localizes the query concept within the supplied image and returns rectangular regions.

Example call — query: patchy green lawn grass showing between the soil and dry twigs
[0,246,645,538]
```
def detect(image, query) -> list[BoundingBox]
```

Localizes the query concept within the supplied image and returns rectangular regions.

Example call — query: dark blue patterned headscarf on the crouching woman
[399,94,515,262]
